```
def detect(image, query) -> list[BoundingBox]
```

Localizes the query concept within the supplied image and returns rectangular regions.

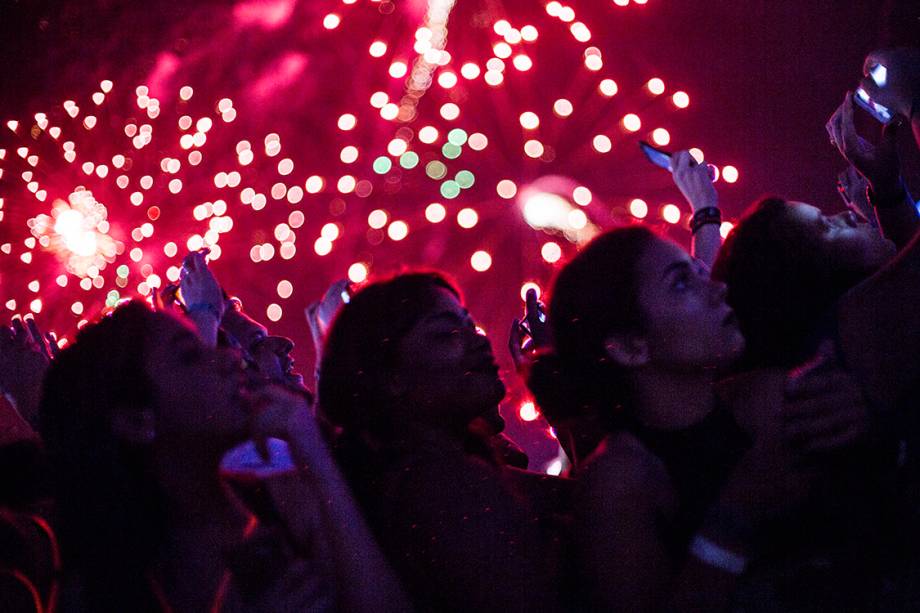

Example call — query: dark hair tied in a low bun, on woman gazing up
[528,226,659,422]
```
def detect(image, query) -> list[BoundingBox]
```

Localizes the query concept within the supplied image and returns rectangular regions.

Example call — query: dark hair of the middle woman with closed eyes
[318,272,460,439]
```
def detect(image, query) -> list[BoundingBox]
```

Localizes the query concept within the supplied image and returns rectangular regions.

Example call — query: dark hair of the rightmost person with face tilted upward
[712,197,864,367]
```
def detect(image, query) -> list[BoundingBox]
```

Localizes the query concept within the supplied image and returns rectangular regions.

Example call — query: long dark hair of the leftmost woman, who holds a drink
[40,301,167,610]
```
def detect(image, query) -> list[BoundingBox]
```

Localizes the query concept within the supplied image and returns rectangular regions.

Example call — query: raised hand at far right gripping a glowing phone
[825,92,901,191]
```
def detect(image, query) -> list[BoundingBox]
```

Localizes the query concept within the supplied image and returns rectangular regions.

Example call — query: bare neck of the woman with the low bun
[633,368,715,430]
